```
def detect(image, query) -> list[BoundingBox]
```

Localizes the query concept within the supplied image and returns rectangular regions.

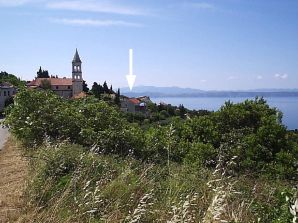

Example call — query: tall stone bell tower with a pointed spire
[72,49,83,96]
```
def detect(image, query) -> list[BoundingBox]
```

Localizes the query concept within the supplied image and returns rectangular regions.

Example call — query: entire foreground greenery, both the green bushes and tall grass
[5,90,298,222]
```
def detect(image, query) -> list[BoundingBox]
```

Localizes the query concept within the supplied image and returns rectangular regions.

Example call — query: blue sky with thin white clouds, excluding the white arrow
[0,0,298,90]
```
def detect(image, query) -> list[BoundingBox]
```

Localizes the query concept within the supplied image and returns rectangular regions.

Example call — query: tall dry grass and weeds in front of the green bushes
[23,143,294,223]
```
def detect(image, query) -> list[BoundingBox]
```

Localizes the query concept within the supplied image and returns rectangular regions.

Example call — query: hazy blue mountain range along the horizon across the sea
[121,86,298,97]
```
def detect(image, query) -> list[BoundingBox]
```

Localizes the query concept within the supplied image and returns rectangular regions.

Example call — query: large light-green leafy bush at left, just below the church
[6,90,142,155]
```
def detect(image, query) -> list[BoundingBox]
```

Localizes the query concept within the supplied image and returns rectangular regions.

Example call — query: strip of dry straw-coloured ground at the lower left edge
[0,139,28,223]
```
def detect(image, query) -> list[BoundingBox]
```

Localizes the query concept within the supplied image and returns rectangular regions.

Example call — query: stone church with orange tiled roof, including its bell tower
[27,49,83,98]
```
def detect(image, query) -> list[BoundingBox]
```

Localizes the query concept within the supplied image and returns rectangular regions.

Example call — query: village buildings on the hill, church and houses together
[0,49,152,115]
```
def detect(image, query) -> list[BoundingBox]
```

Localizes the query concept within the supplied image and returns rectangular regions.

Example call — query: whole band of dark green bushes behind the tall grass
[6,90,298,180]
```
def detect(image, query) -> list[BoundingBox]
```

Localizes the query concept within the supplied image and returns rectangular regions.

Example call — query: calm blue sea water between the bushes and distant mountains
[151,97,298,129]
